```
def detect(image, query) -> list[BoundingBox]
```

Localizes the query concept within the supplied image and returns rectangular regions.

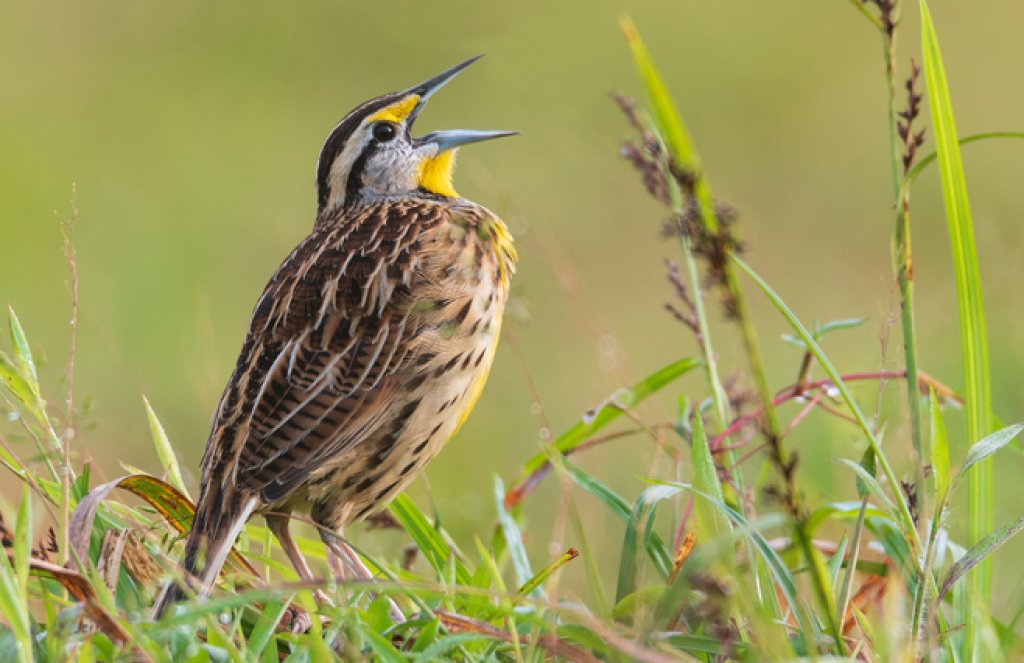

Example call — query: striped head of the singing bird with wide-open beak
[316,55,518,213]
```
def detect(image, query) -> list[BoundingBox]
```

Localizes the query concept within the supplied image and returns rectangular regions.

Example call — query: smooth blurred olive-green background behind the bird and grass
[0,0,1024,602]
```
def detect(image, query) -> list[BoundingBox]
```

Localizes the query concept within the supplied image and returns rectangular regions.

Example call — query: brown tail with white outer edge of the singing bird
[153,493,258,619]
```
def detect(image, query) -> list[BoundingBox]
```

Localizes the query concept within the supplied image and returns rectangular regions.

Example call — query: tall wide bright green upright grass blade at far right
[921,0,993,658]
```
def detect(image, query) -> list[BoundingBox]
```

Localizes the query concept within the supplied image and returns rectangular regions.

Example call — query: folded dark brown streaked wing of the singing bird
[230,204,443,501]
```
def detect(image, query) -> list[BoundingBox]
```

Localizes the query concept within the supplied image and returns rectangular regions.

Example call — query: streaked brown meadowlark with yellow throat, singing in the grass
[154,55,518,618]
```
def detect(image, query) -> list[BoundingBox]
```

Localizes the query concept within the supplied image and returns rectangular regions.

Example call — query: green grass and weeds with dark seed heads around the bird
[0,2,1024,662]
